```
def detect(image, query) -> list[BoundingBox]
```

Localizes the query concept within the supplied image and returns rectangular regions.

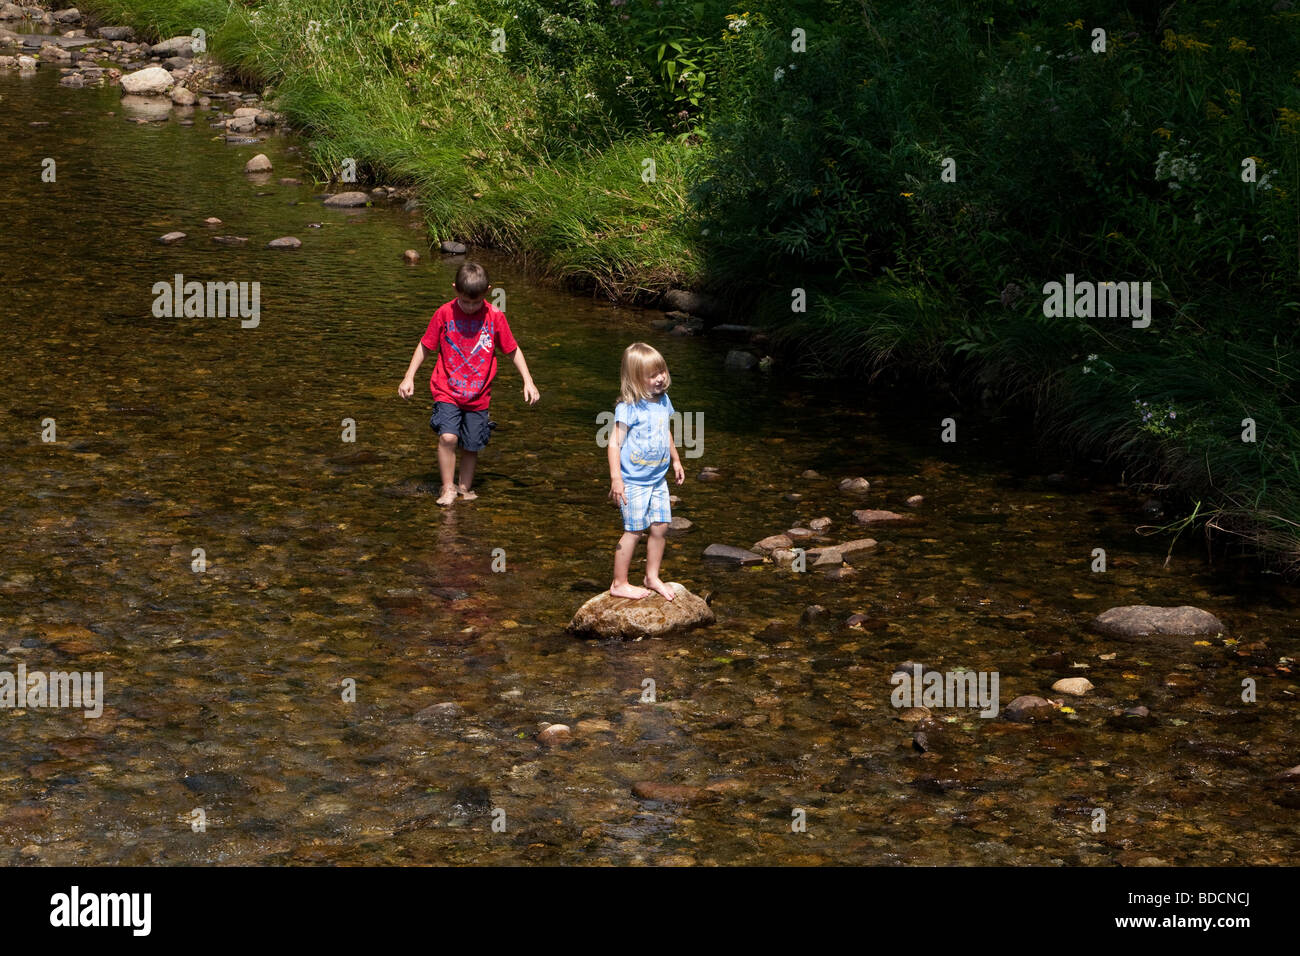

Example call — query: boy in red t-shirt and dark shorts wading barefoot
[398,263,541,505]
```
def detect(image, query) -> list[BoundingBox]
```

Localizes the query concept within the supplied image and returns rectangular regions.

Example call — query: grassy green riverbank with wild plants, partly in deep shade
[25,0,1300,571]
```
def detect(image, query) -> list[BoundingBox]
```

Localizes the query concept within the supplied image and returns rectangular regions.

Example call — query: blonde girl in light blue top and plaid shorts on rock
[610,342,686,601]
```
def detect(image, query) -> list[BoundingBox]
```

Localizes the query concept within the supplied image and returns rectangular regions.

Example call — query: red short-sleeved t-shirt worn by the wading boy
[420,299,519,411]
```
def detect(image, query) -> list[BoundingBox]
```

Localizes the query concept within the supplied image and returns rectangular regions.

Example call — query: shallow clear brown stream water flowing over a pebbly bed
[0,70,1300,864]
